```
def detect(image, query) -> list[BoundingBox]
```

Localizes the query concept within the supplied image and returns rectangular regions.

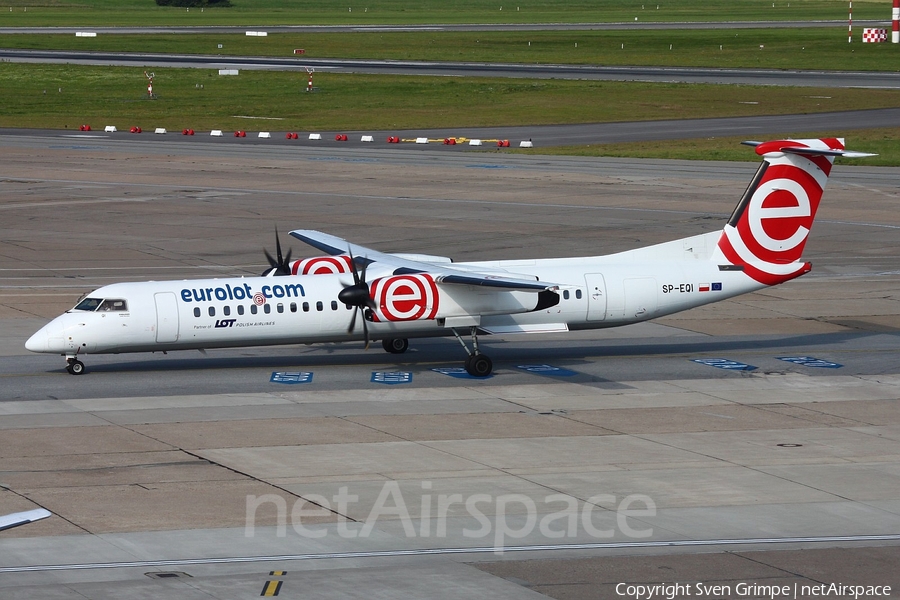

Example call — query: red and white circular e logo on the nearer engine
[370,274,440,322]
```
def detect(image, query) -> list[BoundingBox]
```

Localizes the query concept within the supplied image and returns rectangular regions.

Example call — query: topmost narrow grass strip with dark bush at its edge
[0,0,890,27]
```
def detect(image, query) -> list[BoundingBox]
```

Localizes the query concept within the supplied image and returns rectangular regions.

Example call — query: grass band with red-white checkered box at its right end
[2,27,900,71]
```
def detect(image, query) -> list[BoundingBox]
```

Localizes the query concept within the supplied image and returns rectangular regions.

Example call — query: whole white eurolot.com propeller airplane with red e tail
[25,138,872,377]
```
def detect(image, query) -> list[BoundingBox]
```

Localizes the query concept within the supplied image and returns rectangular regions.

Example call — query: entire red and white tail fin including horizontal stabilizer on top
[714,138,874,285]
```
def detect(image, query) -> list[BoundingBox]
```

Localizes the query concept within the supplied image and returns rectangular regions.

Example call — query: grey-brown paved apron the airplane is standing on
[0,132,900,600]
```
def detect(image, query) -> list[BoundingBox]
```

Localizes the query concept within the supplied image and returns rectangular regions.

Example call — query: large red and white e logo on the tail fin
[719,140,843,285]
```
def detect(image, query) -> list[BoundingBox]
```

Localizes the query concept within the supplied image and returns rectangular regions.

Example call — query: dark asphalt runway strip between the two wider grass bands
[0,49,900,89]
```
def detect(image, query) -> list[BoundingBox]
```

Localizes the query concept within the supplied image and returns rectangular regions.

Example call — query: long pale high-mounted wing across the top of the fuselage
[291,229,561,293]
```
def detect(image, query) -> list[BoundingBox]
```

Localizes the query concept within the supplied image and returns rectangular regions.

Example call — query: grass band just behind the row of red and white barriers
[0,63,900,131]
